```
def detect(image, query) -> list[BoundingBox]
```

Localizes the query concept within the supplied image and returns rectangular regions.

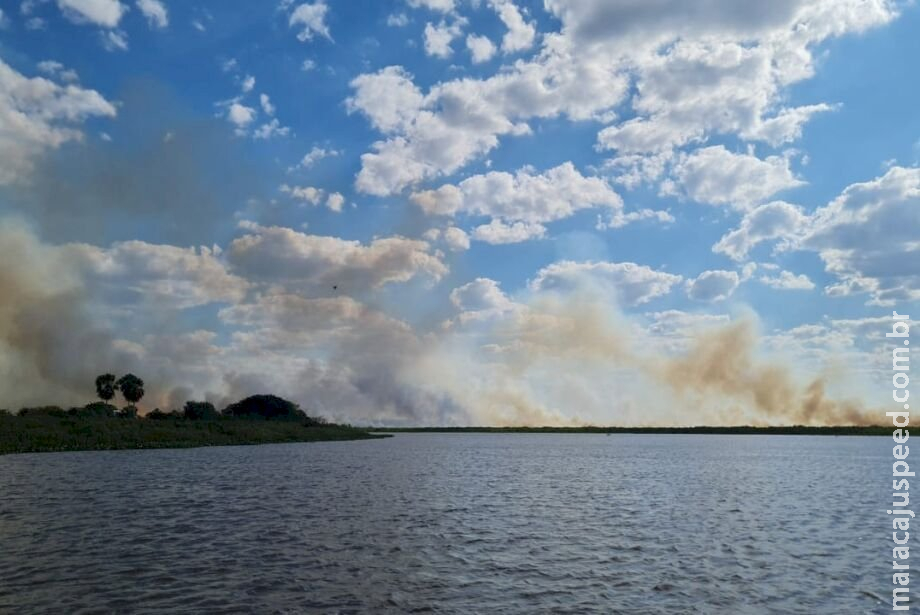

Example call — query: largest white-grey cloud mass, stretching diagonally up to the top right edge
[352,0,896,198]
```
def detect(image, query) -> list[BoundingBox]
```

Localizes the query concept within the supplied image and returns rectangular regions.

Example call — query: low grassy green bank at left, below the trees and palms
[0,415,387,454]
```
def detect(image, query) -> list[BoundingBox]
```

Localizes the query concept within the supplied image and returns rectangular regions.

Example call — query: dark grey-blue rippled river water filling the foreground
[0,434,891,614]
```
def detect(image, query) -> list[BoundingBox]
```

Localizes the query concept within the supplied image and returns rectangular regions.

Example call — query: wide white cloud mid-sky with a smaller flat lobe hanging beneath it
[411,162,623,243]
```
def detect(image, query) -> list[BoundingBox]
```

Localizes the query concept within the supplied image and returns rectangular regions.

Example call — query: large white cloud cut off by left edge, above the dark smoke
[0,60,116,185]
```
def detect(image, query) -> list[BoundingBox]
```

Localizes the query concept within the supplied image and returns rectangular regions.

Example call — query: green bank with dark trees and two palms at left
[0,374,386,454]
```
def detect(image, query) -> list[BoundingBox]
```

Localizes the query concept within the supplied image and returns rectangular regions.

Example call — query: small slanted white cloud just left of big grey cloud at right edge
[712,201,808,261]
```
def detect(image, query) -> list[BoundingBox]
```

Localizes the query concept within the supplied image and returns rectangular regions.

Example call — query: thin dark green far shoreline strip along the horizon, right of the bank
[368,425,891,436]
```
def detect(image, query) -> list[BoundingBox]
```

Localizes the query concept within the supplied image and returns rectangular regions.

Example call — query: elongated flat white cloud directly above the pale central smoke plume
[530,261,682,306]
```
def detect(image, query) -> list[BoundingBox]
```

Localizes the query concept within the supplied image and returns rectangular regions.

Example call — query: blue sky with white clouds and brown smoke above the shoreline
[0,0,920,425]
